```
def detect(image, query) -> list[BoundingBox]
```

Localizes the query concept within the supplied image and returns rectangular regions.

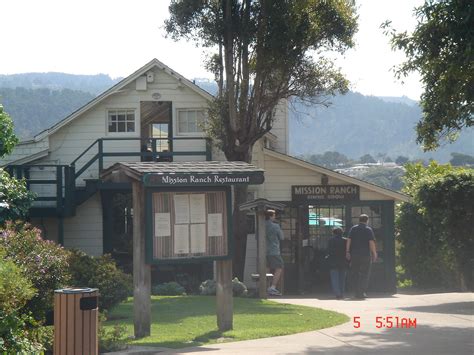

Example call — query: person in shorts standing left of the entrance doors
[265,210,283,296]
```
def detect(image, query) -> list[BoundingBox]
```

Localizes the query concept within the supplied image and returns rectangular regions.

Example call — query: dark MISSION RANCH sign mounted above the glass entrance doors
[291,185,360,203]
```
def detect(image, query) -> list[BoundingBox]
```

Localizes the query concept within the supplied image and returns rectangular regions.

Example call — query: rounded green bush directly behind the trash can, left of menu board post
[69,250,132,310]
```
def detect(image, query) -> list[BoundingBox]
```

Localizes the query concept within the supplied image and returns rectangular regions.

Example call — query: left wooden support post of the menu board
[132,181,151,338]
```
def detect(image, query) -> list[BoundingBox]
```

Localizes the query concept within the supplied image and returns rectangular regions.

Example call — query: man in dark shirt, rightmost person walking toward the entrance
[346,214,377,299]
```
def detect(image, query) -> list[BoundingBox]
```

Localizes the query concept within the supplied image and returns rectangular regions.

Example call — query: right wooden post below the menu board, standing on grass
[216,260,234,332]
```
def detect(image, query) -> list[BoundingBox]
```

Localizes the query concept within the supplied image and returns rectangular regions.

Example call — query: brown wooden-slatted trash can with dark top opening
[53,288,99,355]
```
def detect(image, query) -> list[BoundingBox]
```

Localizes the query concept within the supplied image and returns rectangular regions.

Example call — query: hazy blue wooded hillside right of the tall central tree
[290,93,474,162]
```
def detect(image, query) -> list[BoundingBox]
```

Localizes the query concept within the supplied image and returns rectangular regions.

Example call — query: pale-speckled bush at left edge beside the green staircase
[0,168,35,226]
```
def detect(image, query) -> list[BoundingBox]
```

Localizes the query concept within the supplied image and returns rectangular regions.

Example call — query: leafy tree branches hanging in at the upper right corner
[382,0,474,150]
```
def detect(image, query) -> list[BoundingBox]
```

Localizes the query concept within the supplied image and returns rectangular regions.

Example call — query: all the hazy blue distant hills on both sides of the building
[0,73,474,162]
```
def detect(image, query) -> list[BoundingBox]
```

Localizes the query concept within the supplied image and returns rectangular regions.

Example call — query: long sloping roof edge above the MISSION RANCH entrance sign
[264,148,411,202]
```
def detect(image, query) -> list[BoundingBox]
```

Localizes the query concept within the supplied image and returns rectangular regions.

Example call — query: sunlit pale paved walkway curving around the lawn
[107,293,474,355]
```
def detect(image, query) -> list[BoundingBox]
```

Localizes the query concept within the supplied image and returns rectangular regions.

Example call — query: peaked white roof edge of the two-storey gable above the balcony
[34,58,214,142]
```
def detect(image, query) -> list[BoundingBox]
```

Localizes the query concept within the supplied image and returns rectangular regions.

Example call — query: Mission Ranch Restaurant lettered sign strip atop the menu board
[143,171,264,187]
